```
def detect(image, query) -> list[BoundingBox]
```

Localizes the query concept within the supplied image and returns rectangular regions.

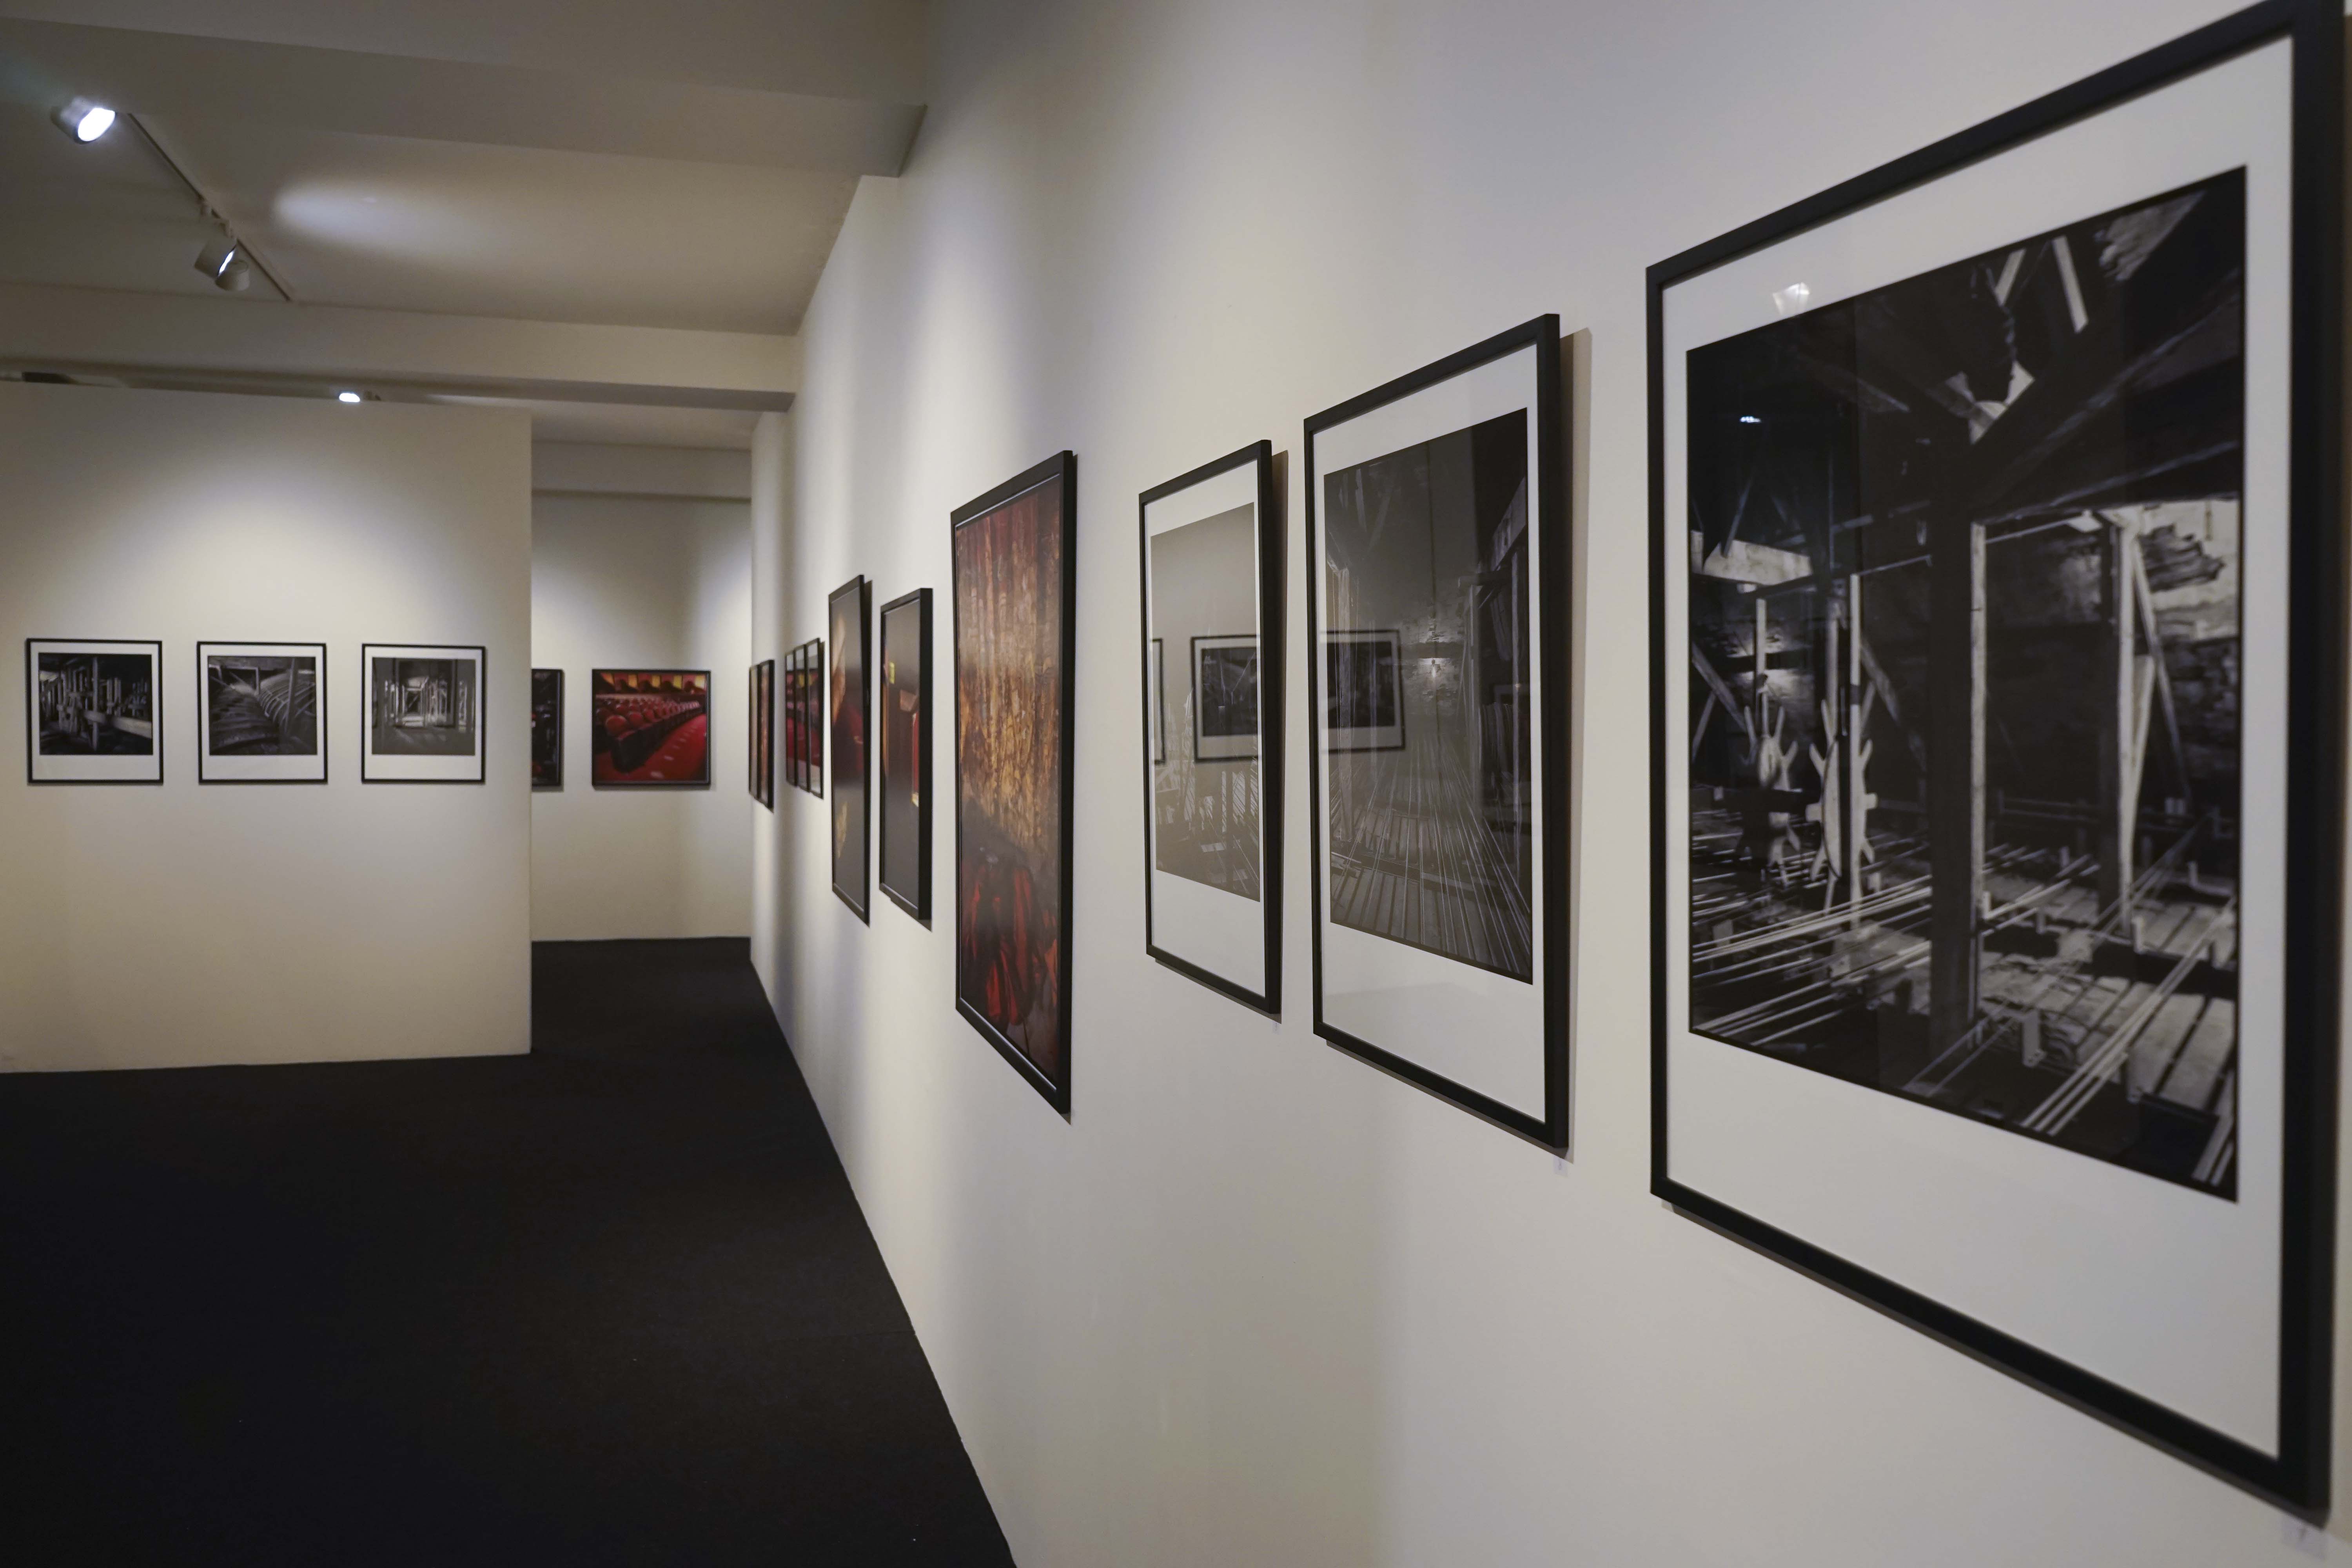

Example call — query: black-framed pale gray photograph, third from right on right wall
[1138,442,1287,1013]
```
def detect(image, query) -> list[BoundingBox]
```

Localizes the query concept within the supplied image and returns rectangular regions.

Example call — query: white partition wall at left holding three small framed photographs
[0,386,532,1070]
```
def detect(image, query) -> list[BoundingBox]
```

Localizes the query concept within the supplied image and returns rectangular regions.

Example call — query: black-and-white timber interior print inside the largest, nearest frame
[1686,172,2246,1199]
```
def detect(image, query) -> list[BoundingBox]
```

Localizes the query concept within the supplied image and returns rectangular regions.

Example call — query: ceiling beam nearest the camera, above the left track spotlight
[0,19,922,174]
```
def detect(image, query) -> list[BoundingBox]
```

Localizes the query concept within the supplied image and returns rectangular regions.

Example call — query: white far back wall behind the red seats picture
[532,484,757,940]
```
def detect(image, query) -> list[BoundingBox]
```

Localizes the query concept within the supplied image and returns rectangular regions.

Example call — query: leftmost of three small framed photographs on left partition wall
[24,637,162,783]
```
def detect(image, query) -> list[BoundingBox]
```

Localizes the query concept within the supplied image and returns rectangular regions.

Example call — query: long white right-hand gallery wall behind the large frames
[755,0,2352,1568]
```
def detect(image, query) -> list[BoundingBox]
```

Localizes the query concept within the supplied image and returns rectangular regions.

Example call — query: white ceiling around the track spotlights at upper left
[0,0,924,446]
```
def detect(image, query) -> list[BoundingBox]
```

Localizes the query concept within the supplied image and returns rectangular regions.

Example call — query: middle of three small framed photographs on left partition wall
[195,642,327,783]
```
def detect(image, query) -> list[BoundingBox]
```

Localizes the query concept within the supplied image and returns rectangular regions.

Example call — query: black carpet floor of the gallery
[0,940,1011,1568]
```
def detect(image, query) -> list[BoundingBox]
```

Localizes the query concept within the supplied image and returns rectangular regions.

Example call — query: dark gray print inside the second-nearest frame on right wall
[1322,409,1534,980]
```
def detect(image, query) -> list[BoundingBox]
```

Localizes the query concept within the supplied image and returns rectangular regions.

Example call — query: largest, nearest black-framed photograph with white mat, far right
[1649,0,2345,1509]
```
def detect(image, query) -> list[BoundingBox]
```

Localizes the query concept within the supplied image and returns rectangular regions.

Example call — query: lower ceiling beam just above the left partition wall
[0,285,800,409]
